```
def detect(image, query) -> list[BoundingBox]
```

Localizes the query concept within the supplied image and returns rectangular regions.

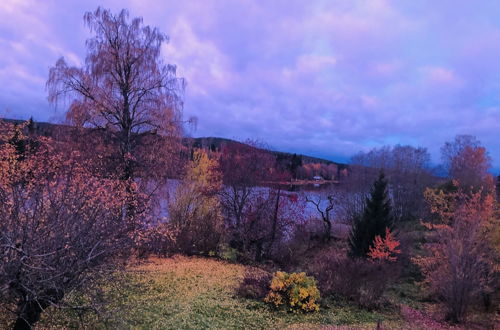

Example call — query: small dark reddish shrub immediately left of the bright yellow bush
[237,267,272,300]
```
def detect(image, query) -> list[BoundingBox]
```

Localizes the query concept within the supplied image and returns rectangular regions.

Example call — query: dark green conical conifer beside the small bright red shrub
[349,172,392,258]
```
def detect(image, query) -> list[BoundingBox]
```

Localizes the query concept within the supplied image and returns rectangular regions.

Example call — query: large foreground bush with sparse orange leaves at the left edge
[0,125,144,329]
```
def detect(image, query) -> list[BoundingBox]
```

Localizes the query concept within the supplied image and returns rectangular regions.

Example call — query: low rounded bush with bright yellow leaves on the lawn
[264,272,320,312]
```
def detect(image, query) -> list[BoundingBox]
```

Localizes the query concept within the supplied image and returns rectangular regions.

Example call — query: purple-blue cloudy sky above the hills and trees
[0,0,500,173]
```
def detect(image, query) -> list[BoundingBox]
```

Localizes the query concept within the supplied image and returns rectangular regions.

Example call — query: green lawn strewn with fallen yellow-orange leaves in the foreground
[39,257,411,329]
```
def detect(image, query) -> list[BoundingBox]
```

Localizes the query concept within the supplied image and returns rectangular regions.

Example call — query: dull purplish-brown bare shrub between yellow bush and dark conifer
[309,249,400,310]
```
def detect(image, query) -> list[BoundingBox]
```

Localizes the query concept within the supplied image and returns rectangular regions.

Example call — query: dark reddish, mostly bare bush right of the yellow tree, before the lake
[220,141,304,261]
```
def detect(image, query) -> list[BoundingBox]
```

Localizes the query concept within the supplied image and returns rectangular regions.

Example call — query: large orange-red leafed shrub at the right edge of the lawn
[413,187,499,322]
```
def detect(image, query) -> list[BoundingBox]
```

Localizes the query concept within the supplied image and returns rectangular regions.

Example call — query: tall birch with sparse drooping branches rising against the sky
[47,8,185,180]
